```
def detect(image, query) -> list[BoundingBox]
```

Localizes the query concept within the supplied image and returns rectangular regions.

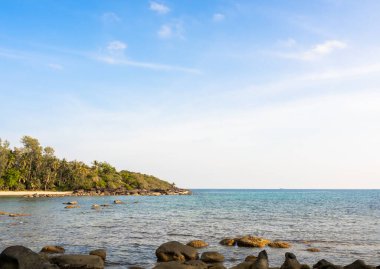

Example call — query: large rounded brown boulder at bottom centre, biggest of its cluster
[156,241,199,262]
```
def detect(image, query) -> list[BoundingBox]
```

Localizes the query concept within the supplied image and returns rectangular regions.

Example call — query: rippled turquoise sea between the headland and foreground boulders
[0,190,380,269]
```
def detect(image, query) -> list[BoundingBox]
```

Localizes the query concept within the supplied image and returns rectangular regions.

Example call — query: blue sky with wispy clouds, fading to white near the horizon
[0,0,380,189]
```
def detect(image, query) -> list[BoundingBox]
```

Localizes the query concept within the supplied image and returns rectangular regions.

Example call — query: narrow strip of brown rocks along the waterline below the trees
[24,188,192,198]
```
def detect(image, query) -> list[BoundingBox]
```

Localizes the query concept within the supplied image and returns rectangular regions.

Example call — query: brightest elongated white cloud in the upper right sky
[277,40,347,61]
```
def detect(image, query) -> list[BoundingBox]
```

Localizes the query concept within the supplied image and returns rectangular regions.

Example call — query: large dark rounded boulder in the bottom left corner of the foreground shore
[0,246,59,269]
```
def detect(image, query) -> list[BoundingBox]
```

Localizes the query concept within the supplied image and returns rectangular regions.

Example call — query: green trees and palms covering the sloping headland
[0,136,174,191]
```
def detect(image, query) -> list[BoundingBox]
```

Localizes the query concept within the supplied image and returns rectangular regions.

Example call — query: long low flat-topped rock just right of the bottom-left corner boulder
[50,255,104,269]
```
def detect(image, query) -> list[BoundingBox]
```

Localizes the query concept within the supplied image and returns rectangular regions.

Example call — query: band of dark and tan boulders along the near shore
[0,236,380,269]
